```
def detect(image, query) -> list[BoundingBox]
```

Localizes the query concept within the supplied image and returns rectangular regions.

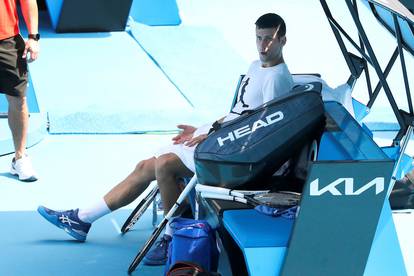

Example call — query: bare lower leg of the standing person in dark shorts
[6,95,29,160]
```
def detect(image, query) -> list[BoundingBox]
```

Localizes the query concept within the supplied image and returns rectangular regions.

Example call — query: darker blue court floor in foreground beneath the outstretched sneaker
[0,210,162,275]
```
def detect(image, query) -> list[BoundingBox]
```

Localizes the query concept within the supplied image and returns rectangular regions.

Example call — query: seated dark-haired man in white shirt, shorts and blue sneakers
[38,13,293,265]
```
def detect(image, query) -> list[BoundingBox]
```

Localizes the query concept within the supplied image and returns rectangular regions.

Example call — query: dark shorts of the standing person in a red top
[0,35,27,97]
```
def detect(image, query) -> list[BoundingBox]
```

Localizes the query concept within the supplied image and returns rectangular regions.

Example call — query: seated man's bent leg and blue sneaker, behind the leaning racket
[143,153,194,265]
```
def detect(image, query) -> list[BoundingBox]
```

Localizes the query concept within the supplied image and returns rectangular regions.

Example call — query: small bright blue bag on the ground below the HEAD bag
[165,218,219,272]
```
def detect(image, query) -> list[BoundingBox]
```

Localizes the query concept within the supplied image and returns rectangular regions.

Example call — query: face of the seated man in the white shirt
[256,27,286,67]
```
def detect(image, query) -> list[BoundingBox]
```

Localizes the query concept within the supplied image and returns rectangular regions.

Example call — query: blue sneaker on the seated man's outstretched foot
[37,206,91,242]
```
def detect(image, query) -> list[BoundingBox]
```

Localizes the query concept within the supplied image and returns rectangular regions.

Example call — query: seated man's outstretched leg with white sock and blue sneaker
[38,157,156,241]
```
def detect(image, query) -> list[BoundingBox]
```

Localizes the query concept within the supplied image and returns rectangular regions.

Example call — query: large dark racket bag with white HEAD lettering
[194,82,325,188]
